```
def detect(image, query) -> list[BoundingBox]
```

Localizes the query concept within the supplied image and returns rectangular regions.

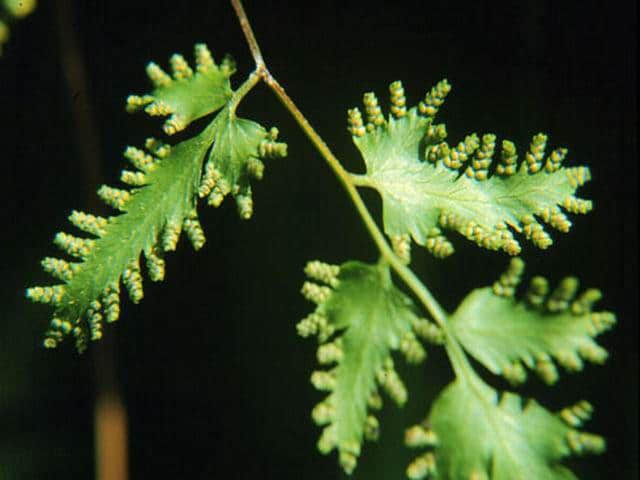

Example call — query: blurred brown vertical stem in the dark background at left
[56,0,128,480]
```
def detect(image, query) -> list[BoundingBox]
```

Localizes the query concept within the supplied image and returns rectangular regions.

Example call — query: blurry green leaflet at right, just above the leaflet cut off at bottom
[450,258,615,384]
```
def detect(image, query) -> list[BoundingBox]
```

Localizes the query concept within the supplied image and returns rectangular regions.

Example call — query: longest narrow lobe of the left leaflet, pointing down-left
[27,124,214,350]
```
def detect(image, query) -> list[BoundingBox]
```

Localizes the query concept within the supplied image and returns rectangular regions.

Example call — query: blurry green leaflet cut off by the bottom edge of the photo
[405,379,605,480]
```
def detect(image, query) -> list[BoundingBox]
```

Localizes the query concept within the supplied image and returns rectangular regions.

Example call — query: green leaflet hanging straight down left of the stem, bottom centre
[298,261,430,473]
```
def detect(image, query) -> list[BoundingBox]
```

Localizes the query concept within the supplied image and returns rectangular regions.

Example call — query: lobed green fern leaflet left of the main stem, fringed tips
[27,46,286,351]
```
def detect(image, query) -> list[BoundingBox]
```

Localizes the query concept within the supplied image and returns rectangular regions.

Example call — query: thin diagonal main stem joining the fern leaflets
[231,0,477,381]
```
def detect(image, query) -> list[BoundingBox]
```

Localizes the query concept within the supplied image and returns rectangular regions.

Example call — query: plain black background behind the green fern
[0,0,638,479]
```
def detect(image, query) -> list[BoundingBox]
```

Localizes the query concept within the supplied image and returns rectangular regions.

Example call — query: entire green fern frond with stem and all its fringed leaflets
[22,7,615,480]
